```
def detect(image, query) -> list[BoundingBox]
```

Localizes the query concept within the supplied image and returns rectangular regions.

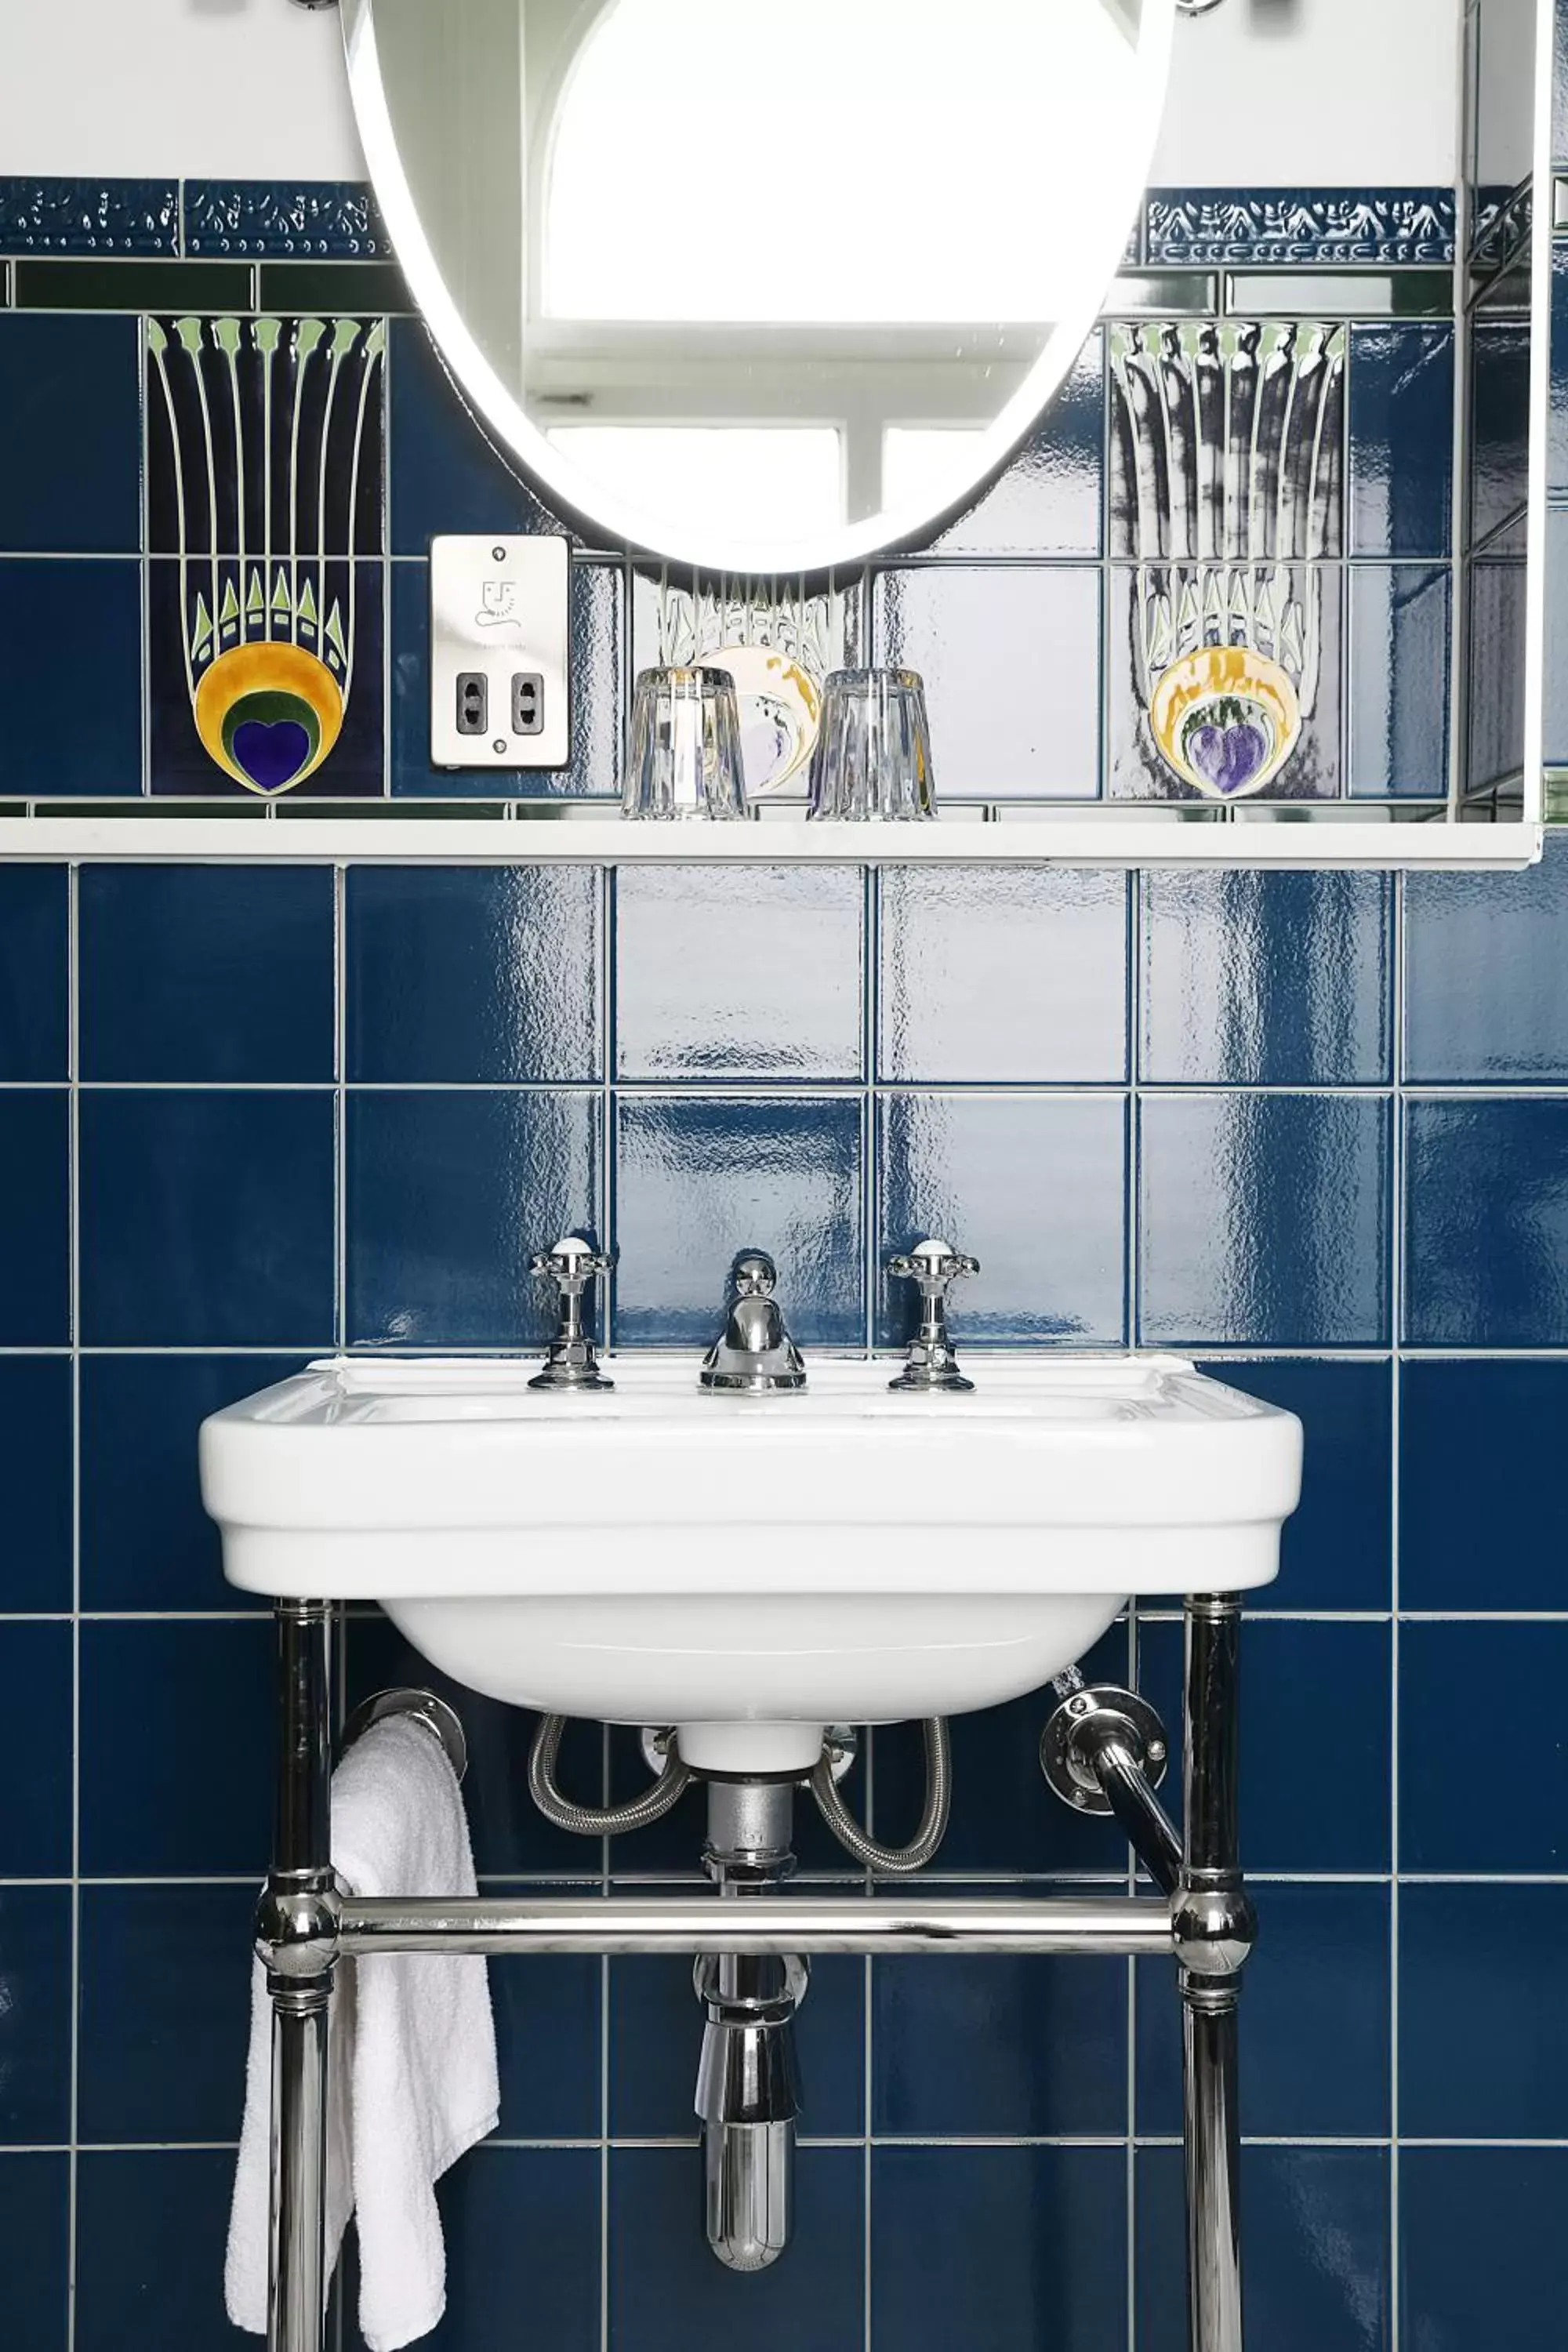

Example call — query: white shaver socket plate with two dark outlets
[430,534,572,771]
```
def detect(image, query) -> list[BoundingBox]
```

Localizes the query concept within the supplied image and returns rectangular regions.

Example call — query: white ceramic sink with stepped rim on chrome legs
[202,1355,1302,1771]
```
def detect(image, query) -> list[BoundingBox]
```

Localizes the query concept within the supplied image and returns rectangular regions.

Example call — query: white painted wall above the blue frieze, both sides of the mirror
[0,0,1457,188]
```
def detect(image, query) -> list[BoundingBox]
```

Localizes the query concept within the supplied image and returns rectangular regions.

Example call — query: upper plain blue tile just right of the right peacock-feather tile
[1349,320,1455,555]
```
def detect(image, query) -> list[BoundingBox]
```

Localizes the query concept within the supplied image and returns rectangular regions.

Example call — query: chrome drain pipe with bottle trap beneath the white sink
[694,1780,808,2270]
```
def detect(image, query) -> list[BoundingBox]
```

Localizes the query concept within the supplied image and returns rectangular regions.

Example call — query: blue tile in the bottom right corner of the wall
[1399,2147,1568,2352]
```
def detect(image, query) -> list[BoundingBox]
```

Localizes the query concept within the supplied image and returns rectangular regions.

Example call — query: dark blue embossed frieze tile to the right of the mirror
[1147,188,1455,268]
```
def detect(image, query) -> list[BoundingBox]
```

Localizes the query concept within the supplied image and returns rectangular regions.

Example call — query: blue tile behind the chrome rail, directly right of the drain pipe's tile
[872,1919,1126,2140]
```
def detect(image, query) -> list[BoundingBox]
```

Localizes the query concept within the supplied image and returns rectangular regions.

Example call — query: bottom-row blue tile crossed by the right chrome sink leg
[1138,2147,1392,2352]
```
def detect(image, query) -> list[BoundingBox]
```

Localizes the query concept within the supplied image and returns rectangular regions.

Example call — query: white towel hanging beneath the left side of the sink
[223,1717,501,2352]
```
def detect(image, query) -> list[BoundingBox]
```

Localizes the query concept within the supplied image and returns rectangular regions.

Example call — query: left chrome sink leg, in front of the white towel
[256,1602,336,2352]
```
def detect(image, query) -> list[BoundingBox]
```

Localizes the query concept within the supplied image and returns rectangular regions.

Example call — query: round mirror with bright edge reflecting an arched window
[343,0,1175,574]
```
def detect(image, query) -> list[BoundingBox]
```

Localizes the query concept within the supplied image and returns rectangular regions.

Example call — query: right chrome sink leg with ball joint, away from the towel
[1173,1595,1255,2352]
